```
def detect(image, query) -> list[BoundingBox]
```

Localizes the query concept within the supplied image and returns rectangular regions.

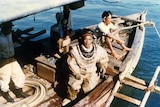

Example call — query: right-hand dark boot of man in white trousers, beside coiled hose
[11,88,29,98]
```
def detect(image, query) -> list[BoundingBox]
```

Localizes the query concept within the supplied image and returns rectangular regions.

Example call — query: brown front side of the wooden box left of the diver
[37,62,56,83]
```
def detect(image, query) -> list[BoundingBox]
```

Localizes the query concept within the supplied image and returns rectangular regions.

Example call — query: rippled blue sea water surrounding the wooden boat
[13,0,160,107]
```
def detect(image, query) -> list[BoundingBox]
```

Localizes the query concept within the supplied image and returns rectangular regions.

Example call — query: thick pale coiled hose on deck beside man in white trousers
[3,79,47,107]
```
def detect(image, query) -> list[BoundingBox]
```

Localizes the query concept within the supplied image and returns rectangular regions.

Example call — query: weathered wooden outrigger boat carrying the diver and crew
[0,0,160,107]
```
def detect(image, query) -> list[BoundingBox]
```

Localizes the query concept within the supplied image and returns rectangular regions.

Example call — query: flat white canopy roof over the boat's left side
[0,0,81,23]
